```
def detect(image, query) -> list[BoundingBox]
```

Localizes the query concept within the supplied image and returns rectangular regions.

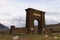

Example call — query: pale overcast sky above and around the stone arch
[0,0,60,27]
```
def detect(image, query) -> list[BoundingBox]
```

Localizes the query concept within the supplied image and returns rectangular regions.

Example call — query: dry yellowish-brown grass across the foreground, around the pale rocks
[0,33,60,40]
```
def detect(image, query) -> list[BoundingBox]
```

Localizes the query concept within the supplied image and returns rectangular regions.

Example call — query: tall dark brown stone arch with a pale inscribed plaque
[26,8,45,34]
